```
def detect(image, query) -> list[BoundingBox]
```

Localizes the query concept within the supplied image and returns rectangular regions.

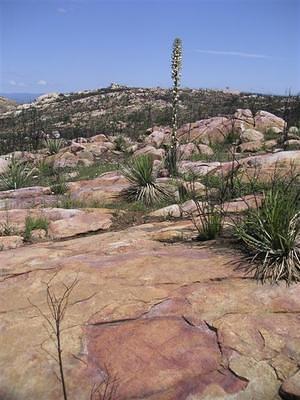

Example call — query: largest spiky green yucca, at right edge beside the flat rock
[234,185,300,284]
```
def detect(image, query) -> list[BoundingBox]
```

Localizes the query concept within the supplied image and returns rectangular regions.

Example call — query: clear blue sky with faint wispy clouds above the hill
[0,0,300,94]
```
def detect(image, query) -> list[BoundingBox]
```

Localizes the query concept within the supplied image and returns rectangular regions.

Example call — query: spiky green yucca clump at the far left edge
[0,157,33,190]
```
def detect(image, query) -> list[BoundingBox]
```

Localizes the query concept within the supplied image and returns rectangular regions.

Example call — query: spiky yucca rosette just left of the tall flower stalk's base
[121,155,170,206]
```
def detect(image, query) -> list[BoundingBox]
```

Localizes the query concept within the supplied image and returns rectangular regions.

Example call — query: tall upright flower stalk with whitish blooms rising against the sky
[167,38,182,176]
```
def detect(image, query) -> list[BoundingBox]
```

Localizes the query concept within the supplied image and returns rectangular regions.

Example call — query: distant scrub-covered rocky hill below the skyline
[0,85,300,146]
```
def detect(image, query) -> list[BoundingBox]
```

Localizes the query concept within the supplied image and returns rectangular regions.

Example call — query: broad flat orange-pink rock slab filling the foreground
[0,221,300,400]
